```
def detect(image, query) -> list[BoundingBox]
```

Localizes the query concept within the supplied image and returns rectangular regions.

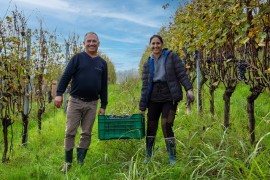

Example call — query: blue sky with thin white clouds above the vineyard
[0,0,186,71]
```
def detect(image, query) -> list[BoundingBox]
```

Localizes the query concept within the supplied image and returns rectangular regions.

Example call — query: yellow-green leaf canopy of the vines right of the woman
[156,0,270,89]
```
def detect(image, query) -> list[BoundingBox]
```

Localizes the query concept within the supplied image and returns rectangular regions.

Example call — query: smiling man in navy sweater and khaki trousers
[54,32,108,173]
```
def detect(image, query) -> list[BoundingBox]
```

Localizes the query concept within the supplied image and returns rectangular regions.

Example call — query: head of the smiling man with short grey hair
[84,34,99,54]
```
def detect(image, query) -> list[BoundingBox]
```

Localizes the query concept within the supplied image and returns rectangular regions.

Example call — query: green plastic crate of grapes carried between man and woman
[98,114,145,140]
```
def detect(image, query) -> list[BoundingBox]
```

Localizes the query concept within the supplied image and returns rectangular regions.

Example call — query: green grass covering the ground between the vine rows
[0,80,270,180]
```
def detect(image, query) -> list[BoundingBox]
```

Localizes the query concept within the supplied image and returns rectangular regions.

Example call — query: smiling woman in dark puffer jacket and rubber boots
[139,35,194,165]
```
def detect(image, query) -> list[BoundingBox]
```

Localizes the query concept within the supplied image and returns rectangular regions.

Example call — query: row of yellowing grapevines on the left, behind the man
[0,6,116,162]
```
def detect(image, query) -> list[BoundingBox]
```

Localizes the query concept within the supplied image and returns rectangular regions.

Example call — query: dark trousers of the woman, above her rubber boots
[146,101,178,138]
